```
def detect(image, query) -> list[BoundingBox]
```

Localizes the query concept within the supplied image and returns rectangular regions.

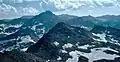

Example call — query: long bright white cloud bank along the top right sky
[42,0,119,10]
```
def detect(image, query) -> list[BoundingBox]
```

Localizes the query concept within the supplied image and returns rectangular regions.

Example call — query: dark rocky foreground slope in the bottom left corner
[0,50,45,62]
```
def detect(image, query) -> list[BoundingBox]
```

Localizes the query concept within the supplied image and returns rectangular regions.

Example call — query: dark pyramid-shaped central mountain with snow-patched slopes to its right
[27,22,120,62]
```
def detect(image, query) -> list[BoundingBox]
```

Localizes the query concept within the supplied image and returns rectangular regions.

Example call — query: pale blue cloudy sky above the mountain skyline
[0,0,120,18]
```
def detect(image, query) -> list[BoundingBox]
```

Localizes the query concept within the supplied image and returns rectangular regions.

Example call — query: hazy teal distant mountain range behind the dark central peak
[0,11,120,50]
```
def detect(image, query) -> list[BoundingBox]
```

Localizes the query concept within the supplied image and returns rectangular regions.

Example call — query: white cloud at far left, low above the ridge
[0,3,39,18]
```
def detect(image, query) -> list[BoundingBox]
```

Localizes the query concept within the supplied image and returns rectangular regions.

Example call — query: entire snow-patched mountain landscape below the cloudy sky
[0,11,120,62]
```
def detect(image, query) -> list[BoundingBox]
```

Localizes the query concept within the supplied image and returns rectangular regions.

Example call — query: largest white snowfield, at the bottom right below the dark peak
[66,48,120,62]
